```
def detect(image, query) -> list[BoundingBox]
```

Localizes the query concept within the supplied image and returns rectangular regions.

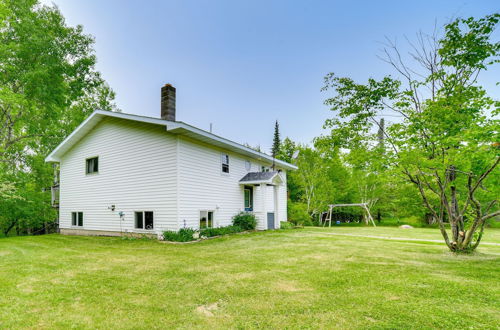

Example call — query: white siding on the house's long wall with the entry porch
[178,138,286,229]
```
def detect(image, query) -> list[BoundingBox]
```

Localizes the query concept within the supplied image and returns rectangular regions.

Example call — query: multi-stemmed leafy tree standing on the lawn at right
[325,14,500,252]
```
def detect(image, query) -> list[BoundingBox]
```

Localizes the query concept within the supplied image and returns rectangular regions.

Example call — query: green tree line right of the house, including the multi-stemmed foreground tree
[277,13,500,252]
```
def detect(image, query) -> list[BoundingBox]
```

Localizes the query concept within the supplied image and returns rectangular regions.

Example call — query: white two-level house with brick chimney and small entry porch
[46,84,297,235]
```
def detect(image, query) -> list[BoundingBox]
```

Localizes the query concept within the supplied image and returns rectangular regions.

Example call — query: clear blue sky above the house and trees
[44,0,500,152]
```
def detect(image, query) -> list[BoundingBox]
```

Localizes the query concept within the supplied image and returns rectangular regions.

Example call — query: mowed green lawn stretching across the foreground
[0,227,500,329]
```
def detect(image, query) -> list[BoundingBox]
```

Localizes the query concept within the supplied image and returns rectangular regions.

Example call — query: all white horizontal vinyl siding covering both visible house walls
[60,117,286,233]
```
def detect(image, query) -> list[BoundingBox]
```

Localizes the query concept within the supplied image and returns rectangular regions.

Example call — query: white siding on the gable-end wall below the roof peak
[60,117,177,232]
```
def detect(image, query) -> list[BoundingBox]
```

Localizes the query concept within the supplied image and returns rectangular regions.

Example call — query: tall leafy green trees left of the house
[0,0,115,236]
